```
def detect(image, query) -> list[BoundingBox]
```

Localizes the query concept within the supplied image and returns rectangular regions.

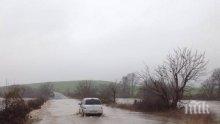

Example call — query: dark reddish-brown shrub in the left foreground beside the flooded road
[0,86,49,124]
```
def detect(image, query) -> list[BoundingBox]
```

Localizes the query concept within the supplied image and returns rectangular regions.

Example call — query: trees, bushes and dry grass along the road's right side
[66,48,220,124]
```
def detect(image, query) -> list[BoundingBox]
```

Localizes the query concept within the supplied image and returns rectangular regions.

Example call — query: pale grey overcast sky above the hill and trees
[0,0,220,83]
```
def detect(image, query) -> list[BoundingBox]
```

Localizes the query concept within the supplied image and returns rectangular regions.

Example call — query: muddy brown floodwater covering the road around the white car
[31,99,177,124]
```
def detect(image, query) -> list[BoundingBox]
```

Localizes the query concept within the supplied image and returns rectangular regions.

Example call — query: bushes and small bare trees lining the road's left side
[0,84,53,124]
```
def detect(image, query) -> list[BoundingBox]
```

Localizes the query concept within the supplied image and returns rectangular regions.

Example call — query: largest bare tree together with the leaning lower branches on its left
[140,48,207,107]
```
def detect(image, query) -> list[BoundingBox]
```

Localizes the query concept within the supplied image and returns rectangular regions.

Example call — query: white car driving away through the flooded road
[79,98,103,116]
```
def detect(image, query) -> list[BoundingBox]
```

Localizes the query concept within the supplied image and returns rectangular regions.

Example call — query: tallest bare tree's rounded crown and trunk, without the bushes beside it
[164,48,207,107]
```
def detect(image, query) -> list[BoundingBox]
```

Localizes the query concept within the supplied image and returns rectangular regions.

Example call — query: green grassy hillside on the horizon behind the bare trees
[25,80,111,93]
